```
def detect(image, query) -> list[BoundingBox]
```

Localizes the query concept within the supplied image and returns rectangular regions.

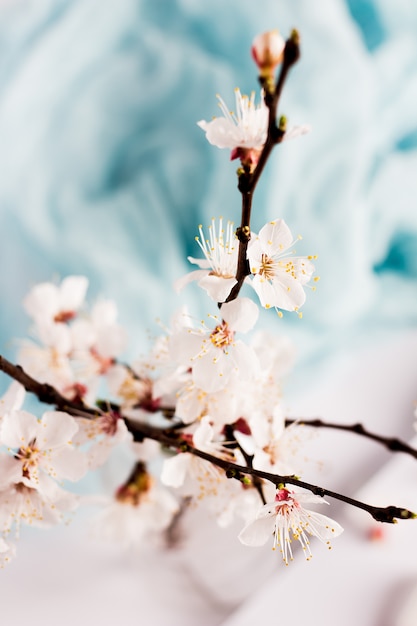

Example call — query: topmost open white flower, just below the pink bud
[198,89,269,159]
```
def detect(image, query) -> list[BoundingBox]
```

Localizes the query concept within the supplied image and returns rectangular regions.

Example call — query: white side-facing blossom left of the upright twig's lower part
[176,218,239,302]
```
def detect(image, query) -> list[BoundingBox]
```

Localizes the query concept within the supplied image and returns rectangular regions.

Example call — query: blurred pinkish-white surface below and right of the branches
[0,332,417,626]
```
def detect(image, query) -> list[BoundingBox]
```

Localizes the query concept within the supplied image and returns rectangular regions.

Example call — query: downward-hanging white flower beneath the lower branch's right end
[239,488,343,565]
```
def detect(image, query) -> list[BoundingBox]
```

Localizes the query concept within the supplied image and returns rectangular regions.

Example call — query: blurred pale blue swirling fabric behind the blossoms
[0,0,417,370]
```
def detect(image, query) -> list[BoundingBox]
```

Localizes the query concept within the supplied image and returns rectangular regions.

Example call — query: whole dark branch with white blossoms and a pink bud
[0,31,417,565]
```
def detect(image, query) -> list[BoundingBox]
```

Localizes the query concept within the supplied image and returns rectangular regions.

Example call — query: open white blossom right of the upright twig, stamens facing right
[247,219,314,311]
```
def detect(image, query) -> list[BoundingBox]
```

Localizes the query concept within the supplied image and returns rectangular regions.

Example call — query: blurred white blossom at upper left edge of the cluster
[23,276,88,323]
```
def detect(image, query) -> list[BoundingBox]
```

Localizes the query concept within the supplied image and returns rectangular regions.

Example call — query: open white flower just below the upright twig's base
[170,298,259,393]
